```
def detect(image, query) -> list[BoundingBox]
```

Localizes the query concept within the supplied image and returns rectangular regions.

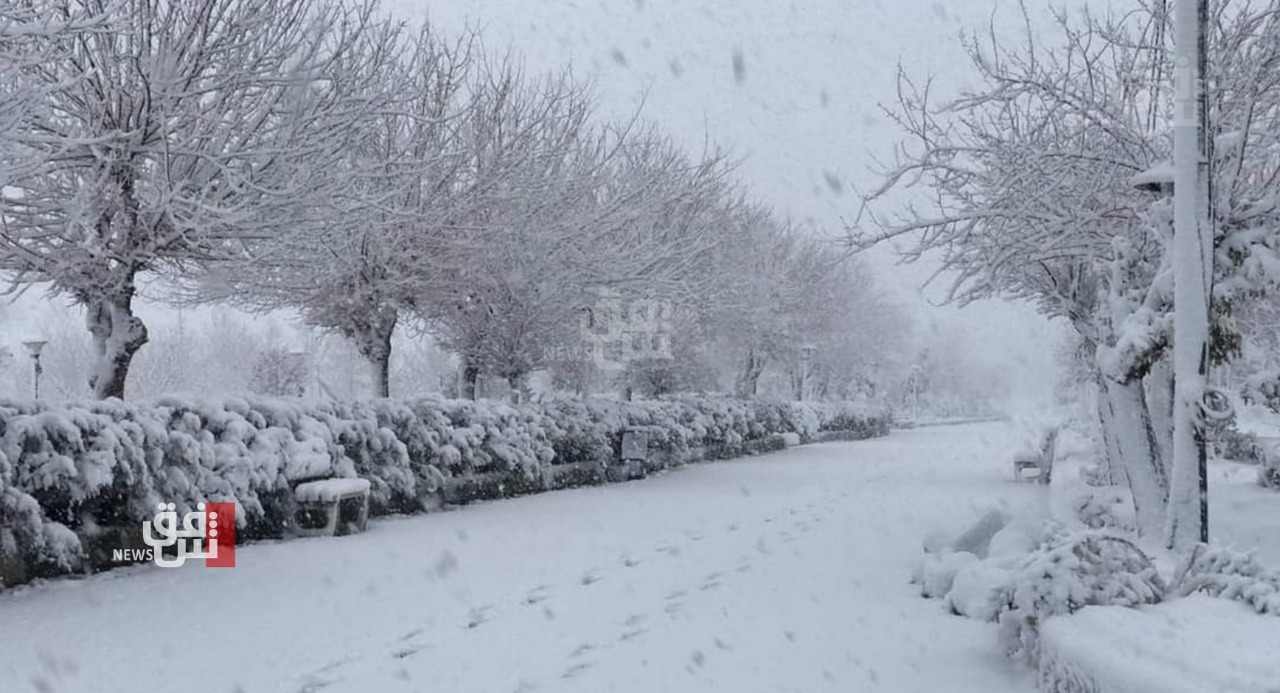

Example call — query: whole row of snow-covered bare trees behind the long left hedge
[0,0,909,398]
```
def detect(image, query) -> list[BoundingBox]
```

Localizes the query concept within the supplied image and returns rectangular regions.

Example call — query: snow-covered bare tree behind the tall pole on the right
[851,3,1280,534]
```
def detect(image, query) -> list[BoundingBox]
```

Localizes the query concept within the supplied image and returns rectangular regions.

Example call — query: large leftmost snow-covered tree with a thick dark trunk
[0,0,394,397]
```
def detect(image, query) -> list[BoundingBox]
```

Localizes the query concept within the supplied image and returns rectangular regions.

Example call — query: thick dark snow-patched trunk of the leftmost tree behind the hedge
[84,286,147,400]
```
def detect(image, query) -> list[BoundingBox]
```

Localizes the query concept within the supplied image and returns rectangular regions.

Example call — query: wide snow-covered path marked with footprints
[0,424,1043,693]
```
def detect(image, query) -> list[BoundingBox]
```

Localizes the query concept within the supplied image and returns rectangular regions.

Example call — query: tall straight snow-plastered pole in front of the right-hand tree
[1165,0,1213,550]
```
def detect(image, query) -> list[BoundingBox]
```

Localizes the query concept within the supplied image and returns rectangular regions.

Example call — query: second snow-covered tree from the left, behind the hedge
[200,20,471,397]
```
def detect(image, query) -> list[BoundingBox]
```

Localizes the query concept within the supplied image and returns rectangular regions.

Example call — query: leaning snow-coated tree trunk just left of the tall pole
[1103,378,1169,537]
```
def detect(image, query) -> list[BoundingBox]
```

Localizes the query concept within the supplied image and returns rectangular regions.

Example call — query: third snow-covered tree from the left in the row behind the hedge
[415,60,728,397]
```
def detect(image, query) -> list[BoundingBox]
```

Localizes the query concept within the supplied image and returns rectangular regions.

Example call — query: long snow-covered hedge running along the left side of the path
[0,396,890,585]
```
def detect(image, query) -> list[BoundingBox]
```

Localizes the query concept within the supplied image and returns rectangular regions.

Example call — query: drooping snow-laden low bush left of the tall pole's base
[998,529,1165,664]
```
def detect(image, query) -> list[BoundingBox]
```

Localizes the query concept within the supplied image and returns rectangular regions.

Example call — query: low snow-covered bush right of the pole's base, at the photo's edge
[1172,544,1280,616]
